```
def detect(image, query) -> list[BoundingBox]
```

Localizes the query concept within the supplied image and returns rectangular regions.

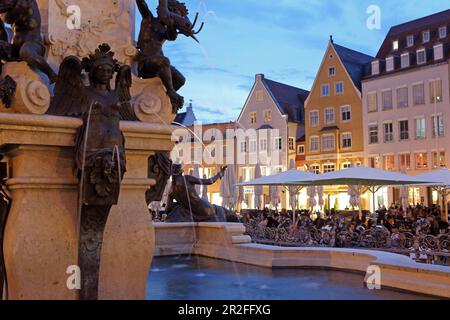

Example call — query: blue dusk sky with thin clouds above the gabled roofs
[137,0,450,123]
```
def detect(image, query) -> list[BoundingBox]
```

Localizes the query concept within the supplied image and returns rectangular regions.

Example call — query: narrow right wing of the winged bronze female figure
[116,65,139,121]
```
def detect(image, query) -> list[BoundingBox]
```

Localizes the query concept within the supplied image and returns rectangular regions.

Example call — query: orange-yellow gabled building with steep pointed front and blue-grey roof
[305,38,374,209]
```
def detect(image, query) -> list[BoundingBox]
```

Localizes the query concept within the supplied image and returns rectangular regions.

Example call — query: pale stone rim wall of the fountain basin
[155,223,450,298]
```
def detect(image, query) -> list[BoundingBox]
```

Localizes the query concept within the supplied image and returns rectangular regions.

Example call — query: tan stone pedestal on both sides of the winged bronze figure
[0,113,173,300]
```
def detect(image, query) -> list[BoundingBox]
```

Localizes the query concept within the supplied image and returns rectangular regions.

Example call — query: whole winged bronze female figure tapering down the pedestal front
[51,44,134,300]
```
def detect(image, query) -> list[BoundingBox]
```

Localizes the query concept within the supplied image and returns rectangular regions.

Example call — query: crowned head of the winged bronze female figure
[82,43,120,88]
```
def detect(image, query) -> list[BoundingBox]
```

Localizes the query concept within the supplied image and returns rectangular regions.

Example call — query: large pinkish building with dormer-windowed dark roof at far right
[363,10,450,206]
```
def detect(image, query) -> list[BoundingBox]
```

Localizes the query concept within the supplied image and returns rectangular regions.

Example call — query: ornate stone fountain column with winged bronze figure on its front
[0,0,200,300]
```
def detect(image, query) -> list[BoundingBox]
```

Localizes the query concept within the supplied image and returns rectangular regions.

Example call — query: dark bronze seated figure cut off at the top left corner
[0,0,57,83]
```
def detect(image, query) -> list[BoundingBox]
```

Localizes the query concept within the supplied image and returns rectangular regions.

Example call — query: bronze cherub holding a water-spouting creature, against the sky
[136,0,203,113]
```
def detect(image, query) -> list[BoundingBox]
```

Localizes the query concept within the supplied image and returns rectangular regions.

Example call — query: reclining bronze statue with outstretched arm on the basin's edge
[166,164,228,222]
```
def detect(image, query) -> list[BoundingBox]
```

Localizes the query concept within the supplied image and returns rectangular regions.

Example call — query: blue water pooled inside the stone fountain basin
[147,256,428,300]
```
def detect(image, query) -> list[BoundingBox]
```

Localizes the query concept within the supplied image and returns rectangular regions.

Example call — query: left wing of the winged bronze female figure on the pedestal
[48,56,91,117]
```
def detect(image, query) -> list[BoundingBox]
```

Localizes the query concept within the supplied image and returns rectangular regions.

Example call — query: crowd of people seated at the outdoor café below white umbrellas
[241,204,450,236]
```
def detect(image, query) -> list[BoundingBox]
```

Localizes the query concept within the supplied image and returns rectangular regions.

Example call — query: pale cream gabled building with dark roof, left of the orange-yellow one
[236,74,309,208]
